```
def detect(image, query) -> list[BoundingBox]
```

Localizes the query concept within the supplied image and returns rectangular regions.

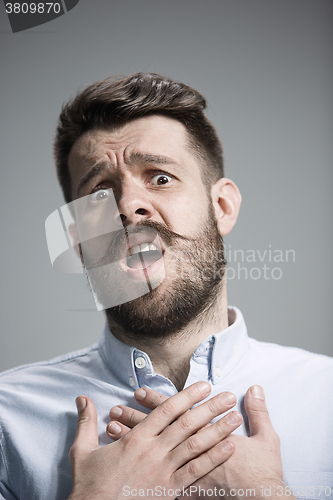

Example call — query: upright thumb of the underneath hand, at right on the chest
[245,385,275,436]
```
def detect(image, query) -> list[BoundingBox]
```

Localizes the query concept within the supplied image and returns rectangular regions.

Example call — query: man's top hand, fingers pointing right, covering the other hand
[69,382,242,500]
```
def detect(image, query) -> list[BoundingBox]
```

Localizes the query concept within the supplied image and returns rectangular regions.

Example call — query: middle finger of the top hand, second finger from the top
[162,392,236,449]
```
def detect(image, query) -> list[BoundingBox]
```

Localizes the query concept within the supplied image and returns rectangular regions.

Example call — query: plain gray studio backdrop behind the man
[0,0,333,370]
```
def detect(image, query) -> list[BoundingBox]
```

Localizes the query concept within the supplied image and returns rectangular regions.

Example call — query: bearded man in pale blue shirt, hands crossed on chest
[0,74,333,500]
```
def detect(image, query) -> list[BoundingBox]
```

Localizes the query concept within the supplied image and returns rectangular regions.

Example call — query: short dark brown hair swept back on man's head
[54,73,224,203]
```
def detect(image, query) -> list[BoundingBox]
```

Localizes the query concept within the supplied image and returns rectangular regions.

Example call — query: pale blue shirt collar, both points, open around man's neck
[99,307,249,390]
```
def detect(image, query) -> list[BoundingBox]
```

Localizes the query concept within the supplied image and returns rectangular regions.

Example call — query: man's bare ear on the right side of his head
[211,177,242,236]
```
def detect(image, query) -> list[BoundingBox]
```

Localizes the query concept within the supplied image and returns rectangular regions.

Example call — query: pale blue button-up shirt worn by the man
[0,308,333,500]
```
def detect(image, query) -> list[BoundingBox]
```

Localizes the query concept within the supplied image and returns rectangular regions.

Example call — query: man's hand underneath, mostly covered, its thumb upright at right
[107,386,294,500]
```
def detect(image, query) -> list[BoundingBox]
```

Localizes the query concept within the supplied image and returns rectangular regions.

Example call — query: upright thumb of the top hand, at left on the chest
[71,396,99,456]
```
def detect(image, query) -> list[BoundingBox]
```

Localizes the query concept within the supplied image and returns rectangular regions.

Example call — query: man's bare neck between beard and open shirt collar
[109,287,228,391]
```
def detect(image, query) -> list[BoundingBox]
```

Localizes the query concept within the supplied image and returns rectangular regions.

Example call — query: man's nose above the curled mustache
[116,182,155,226]
